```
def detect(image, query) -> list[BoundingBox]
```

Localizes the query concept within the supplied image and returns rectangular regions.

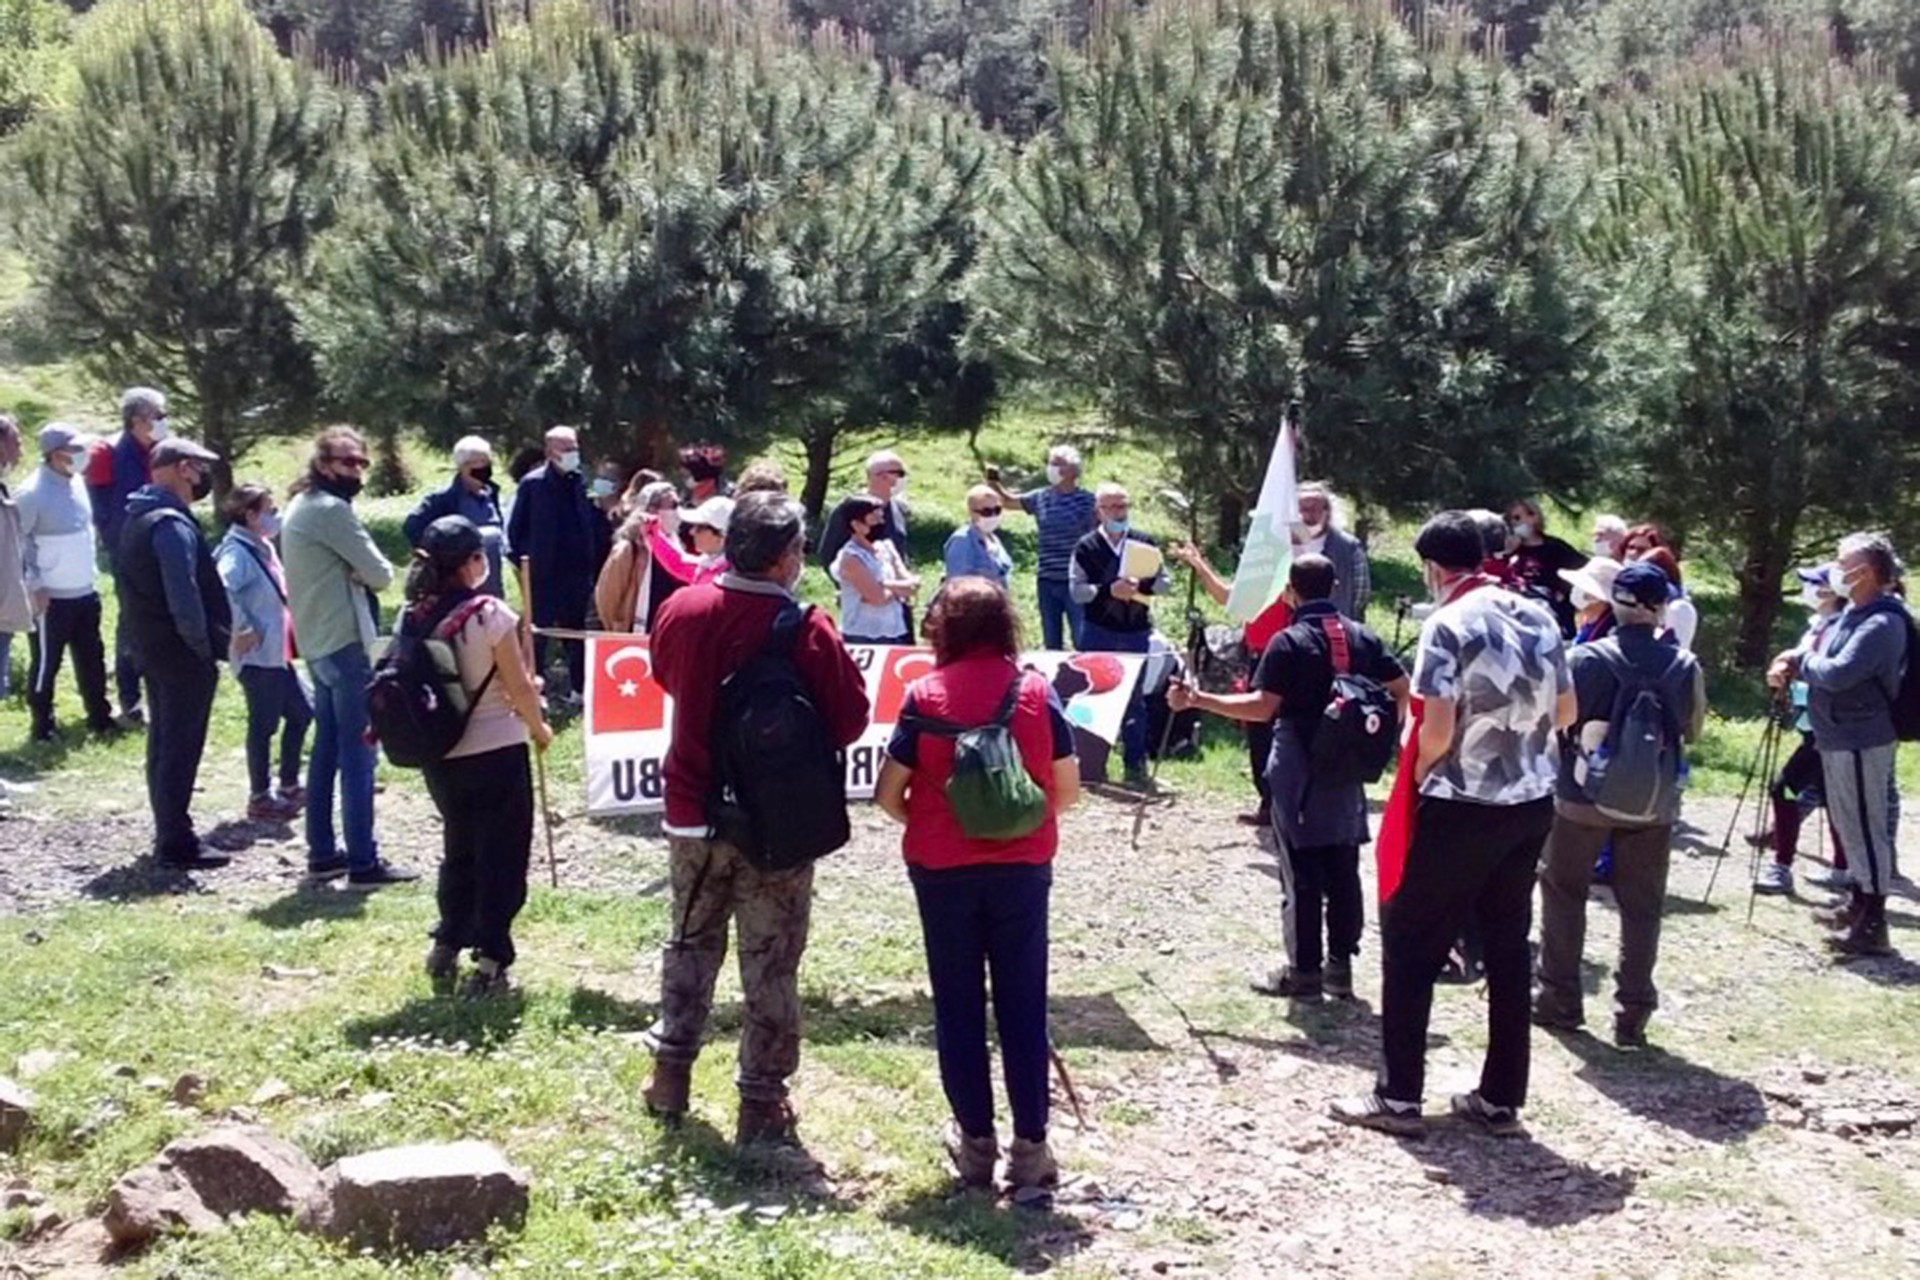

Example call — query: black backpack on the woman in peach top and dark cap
[367,595,493,770]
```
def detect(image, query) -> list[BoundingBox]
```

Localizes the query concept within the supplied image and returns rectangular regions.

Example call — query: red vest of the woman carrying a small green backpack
[887,652,1073,871]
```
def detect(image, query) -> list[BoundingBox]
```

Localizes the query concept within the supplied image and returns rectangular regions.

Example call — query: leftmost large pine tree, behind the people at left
[17,0,348,489]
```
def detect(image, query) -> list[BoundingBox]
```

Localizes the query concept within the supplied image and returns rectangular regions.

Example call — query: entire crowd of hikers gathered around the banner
[0,404,1912,1188]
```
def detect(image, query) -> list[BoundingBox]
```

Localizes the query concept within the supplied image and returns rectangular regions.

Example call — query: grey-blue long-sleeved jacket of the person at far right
[1799,595,1910,750]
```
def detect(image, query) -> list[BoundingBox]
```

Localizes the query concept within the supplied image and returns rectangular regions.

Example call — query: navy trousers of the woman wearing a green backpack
[908,864,1054,1142]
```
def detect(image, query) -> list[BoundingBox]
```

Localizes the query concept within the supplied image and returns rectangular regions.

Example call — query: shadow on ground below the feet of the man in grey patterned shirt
[1407,1119,1638,1230]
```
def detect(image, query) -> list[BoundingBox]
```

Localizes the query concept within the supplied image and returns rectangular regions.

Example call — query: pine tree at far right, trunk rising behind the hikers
[1588,48,1920,664]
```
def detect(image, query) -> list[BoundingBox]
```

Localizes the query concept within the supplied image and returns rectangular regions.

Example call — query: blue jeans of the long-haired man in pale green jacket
[307,645,380,871]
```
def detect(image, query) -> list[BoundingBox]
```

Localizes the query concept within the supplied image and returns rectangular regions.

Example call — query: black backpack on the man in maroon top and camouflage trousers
[708,604,852,871]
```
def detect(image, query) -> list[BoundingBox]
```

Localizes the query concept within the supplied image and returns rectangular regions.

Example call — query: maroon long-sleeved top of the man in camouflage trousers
[653,574,868,835]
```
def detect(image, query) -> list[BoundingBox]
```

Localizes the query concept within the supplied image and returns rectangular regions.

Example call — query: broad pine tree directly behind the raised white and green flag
[977,0,1596,537]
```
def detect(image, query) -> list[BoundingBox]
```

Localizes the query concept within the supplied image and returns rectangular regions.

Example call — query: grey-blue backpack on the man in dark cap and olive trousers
[1580,637,1688,827]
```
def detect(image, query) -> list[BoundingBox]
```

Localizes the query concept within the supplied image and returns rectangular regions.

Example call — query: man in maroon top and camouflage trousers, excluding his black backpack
[645,493,868,1144]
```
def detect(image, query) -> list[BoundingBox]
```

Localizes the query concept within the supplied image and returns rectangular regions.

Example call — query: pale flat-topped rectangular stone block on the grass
[326,1142,526,1249]
